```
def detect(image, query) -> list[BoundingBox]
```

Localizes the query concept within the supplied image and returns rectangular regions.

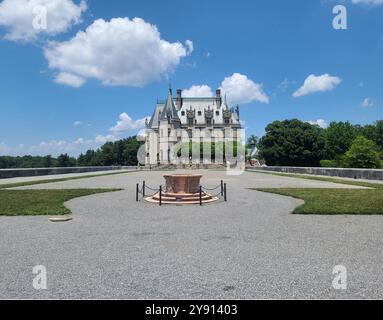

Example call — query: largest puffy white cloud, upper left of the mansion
[44,18,192,87]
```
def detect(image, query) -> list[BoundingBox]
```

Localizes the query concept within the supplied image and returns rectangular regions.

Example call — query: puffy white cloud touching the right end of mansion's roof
[220,73,269,104]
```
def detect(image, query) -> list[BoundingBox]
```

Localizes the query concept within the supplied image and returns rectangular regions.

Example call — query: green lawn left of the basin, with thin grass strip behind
[0,171,129,216]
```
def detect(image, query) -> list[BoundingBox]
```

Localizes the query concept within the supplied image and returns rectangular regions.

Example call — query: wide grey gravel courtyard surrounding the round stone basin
[0,171,383,299]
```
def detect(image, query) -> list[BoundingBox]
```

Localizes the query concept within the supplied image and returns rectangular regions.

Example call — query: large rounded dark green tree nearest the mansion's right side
[258,119,325,167]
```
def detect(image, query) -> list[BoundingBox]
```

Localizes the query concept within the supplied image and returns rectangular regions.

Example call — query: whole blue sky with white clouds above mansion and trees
[0,0,383,155]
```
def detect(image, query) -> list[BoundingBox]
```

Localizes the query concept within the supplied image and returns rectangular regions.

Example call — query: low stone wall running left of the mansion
[0,166,137,179]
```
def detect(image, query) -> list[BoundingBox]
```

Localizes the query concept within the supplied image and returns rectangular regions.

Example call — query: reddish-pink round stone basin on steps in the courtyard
[164,174,202,194]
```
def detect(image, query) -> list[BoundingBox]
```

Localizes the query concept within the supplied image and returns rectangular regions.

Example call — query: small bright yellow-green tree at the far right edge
[343,136,381,169]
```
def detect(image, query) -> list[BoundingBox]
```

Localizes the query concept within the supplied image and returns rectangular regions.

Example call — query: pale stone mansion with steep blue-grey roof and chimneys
[145,89,242,165]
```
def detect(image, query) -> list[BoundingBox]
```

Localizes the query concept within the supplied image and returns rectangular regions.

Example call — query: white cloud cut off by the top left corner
[0,0,87,42]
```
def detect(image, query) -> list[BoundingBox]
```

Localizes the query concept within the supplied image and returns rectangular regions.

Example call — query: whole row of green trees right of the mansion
[256,119,383,168]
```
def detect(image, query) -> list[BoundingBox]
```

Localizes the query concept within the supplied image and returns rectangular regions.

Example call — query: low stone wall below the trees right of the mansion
[251,167,383,180]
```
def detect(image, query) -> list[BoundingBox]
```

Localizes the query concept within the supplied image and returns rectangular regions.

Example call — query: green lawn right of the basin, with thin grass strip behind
[255,171,383,215]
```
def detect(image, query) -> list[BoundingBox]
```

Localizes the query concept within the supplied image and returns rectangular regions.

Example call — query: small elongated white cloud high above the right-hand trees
[293,73,342,98]
